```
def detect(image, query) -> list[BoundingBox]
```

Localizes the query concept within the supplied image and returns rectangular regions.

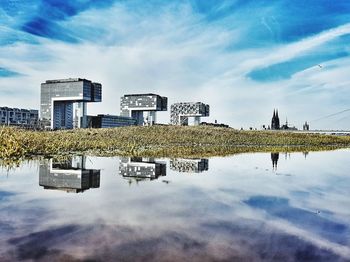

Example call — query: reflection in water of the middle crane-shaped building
[119,157,166,180]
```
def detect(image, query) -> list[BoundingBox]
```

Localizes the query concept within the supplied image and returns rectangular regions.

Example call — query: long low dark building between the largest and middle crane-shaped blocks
[88,115,136,128]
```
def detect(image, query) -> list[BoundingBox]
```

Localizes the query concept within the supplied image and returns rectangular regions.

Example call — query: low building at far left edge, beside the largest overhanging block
[0,107,39,127]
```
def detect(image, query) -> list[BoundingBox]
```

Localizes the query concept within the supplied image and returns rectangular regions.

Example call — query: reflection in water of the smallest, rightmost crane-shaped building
[170,158,209,173]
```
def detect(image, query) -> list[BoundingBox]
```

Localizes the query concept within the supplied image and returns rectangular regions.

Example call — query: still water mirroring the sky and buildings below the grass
[0,150,350,261]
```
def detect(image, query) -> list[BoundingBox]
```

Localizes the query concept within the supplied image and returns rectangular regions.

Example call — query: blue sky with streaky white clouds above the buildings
[0,0,350,130]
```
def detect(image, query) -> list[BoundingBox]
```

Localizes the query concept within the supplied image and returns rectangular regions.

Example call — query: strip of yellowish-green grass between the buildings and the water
[0,126,350,161]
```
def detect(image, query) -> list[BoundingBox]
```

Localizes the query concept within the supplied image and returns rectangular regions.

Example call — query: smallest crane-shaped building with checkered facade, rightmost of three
[170,102,209,125]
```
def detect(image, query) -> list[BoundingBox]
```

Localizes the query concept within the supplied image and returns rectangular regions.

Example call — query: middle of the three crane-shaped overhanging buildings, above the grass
[120,94,168,125]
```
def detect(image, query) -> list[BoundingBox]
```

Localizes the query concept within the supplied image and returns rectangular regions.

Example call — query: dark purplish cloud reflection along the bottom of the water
[2,220,346,261]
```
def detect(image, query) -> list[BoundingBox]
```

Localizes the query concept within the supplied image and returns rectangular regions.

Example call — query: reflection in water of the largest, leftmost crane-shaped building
[39,156,100,193]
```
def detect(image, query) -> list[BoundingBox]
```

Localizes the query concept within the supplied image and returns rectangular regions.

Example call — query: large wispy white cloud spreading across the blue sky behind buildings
[0,4,350,128]
